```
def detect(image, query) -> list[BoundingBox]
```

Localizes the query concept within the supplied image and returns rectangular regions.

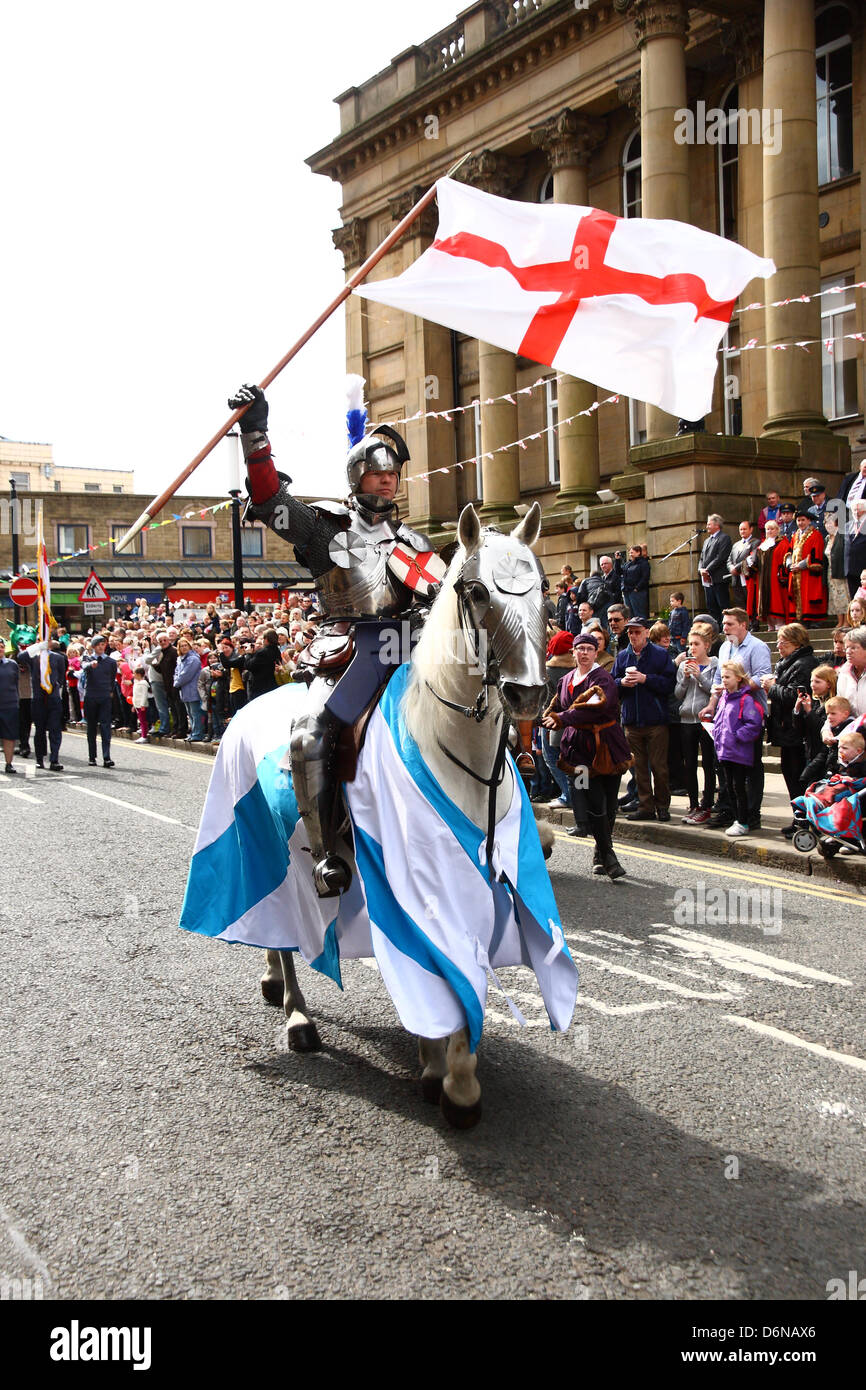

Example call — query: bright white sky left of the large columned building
[0,0,460,496]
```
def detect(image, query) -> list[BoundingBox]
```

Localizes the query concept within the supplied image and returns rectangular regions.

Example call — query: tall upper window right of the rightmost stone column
[815,4,853,183]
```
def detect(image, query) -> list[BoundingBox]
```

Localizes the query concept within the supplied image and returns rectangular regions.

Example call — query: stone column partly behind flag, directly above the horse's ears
[460,150,521,524]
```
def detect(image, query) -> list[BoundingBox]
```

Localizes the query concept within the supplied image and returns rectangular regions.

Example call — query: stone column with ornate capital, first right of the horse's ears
[532,107,606,510]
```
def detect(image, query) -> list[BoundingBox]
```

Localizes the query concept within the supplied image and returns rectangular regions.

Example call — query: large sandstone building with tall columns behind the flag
[307,0,866,607]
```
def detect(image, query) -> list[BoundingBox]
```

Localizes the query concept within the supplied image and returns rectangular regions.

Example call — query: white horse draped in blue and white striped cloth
[181,506,578,1127]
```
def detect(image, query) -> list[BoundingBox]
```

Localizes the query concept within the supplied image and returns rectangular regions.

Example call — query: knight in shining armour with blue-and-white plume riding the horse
[228,378,445,898]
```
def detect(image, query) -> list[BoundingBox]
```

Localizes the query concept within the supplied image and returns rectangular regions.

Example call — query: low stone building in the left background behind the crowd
[0,492,311,631]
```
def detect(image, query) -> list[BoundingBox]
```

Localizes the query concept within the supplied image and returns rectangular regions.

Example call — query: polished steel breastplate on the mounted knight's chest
[316,512,409,617]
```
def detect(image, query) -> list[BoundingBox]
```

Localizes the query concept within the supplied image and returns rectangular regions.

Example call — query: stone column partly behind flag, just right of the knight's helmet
[389,186,457,538]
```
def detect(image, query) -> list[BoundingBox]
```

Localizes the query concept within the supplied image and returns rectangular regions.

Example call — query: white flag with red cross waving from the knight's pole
[354,178,776,420]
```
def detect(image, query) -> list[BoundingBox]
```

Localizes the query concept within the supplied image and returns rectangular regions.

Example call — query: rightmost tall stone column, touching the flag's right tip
[762,0,827,436]
